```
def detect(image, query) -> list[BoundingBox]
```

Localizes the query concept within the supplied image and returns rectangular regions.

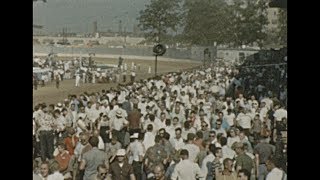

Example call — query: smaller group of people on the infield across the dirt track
[33,56,142,90]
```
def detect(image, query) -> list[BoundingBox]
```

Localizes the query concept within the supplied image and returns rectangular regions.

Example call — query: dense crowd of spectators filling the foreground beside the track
[33,52,287,180]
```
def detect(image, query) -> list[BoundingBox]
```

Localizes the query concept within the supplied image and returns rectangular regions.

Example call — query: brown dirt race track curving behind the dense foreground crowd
[33,57,201,106]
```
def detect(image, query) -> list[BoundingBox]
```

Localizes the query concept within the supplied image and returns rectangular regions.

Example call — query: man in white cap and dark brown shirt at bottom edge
[110,149,136,180]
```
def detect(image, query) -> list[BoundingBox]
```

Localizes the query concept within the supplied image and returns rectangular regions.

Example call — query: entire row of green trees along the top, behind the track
[137,0,287,47]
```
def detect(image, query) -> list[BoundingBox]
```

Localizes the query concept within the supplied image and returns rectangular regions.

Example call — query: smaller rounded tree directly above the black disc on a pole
[137,0,181,41]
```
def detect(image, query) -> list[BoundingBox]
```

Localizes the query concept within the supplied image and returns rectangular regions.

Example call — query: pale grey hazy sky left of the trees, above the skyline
[33,0,150,33]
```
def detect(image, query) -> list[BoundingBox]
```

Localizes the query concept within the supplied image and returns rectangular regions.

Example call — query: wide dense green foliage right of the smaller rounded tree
[183,0,268,46]
